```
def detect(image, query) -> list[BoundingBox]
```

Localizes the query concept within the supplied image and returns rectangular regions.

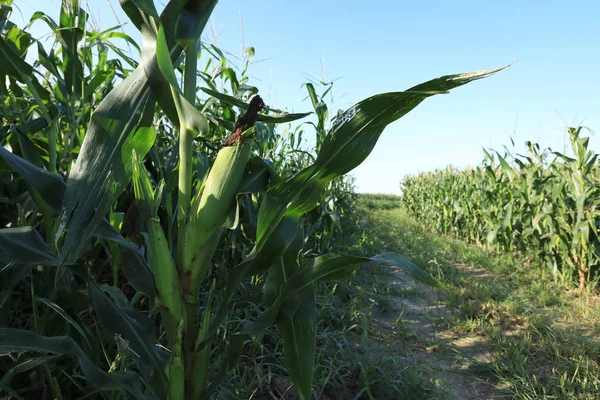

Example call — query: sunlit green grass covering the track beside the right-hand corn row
[336,198,600,399]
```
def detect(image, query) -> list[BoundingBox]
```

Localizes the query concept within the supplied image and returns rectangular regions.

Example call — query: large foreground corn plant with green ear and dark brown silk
[0,0,506,400]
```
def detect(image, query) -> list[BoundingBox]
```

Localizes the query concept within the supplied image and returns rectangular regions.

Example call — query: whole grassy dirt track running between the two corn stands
[326,209,600,400]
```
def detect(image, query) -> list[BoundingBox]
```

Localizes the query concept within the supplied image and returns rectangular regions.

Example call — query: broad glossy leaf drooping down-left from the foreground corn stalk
[57,101,156,262]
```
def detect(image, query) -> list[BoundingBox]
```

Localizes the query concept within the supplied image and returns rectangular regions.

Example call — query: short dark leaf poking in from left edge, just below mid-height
[0,226,60,266]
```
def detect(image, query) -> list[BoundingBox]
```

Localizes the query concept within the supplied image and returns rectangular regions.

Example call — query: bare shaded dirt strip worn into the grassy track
[360,266,510,400]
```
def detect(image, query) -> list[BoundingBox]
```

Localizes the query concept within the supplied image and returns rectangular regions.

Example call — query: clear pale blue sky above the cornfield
[10,0,600,193]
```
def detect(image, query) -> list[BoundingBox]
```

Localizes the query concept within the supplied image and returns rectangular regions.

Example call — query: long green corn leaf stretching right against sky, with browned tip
[257,68,502,246]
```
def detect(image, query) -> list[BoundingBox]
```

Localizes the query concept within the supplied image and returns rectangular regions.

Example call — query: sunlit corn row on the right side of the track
[401,128,600,289]
